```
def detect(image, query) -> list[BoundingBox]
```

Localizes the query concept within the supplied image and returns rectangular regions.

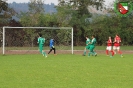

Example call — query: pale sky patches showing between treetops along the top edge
[3,0,114,5]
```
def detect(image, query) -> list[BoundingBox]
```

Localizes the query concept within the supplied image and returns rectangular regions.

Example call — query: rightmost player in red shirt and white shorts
[113,34,123,57]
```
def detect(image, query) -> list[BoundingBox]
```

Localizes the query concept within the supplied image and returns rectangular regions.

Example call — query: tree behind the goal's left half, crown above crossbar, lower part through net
[20,0,44,46]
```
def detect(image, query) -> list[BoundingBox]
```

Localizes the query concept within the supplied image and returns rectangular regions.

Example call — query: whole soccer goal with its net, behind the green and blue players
[2,26,73,55]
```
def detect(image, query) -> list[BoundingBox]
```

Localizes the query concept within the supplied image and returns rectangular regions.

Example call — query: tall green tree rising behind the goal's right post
[56,0,104,45]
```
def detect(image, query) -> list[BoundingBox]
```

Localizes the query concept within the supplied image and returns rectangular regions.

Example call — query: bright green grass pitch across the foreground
[0,54,133,88]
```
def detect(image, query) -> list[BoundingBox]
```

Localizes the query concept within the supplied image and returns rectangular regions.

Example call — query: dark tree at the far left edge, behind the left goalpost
[0,0,16,46]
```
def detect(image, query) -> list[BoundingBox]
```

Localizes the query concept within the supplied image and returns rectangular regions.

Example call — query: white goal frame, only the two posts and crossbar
[2,26,74,55]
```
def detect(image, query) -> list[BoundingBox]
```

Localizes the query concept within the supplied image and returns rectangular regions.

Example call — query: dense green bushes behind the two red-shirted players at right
[90,15,133,45]
